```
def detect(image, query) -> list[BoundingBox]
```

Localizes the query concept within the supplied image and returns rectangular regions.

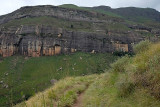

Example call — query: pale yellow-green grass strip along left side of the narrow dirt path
[17,75,99,107]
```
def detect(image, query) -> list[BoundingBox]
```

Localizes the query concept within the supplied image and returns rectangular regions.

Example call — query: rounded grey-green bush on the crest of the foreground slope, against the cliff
[133,40,151,54]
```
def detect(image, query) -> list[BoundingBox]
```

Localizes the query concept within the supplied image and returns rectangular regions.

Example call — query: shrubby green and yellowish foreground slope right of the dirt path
[83,41,160,107]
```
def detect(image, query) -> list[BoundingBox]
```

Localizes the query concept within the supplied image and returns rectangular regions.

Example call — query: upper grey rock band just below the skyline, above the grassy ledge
[0,5,118,24]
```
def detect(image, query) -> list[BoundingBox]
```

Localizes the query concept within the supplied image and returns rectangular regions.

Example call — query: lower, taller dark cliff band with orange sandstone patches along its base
[0,25,157,57]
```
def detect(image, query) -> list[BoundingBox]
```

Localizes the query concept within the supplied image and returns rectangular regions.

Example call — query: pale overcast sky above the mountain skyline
[0,0,160,15]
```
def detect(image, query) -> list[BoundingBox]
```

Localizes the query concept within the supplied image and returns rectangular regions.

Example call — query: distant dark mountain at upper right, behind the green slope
[92,6,160,23]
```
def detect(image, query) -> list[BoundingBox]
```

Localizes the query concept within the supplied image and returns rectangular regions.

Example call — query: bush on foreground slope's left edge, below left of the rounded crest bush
[111,56,130,72]
